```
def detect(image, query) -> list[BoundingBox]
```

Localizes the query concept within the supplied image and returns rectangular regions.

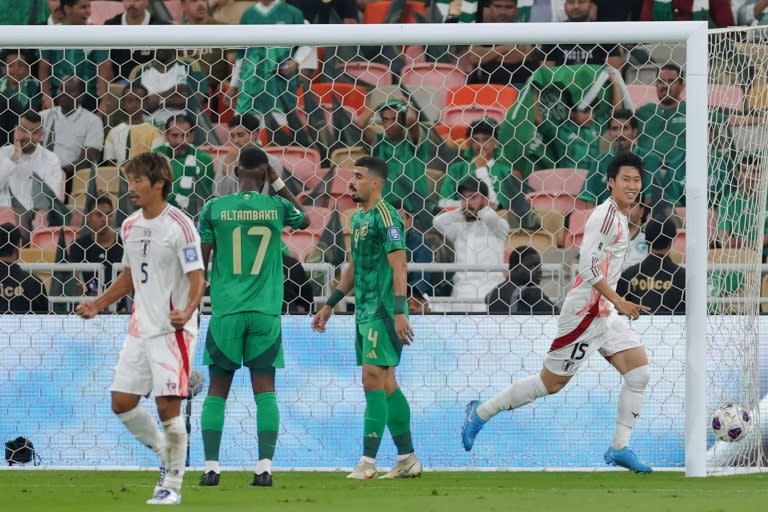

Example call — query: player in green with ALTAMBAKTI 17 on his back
[198,148,309,487]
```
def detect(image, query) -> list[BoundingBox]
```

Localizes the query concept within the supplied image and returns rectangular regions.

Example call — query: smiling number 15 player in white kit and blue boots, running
[462,153,652,473]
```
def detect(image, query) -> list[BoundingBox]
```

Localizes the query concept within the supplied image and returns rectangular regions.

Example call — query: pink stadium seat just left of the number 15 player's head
[528,169,587,215]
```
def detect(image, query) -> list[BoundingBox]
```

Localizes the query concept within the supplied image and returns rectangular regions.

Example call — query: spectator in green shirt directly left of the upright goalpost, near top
[636,63,685,164]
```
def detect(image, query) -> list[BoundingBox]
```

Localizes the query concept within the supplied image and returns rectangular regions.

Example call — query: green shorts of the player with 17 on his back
[203,312,285,371]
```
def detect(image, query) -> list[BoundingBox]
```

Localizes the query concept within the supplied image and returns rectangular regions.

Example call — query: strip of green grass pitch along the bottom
[0,470,768,512]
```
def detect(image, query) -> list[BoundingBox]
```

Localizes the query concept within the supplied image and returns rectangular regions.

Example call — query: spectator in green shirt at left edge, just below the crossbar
[0,48,43,114]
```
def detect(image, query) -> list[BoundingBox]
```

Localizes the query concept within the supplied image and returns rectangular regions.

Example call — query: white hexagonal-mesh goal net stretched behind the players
[0,11,768,474]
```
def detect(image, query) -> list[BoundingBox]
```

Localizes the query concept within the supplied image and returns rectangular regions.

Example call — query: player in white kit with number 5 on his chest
[76,153,205,505]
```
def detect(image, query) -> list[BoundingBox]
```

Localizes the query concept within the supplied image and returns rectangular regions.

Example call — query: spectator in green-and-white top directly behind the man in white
[438,118,531,226]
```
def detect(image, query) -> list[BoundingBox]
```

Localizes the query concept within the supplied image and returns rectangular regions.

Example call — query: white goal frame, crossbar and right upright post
[0,22,708,477]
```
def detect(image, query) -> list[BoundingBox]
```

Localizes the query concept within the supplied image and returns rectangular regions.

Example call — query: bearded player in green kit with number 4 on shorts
[312,157,422,480]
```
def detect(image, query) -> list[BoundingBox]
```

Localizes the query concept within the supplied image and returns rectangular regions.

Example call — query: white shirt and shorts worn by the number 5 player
[111,205,203,397]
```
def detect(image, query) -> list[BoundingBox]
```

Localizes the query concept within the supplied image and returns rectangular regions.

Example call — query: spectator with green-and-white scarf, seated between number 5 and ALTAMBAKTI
[153,114,214,217]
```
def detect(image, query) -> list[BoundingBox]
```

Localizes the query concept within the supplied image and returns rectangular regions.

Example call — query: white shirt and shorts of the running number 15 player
[544,199,641,376]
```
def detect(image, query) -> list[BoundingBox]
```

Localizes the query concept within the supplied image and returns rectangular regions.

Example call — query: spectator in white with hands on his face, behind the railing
[434,177,509,312]
